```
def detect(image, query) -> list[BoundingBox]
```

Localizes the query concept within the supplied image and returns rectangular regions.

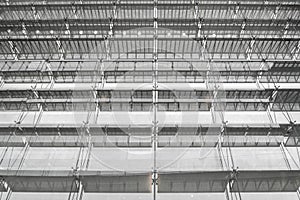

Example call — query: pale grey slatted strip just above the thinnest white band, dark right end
[0,58,300,71]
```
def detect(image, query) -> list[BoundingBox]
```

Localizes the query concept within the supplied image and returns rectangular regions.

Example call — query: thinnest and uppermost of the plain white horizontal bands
[0,80,300,91]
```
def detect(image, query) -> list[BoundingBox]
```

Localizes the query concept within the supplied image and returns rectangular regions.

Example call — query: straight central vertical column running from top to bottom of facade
[152,0,158,200]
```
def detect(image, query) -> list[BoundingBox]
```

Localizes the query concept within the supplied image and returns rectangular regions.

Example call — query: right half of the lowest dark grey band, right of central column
[158,171,300,193]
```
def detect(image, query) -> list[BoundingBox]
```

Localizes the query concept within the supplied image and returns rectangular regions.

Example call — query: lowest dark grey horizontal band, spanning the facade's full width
[0,170,300,193]
